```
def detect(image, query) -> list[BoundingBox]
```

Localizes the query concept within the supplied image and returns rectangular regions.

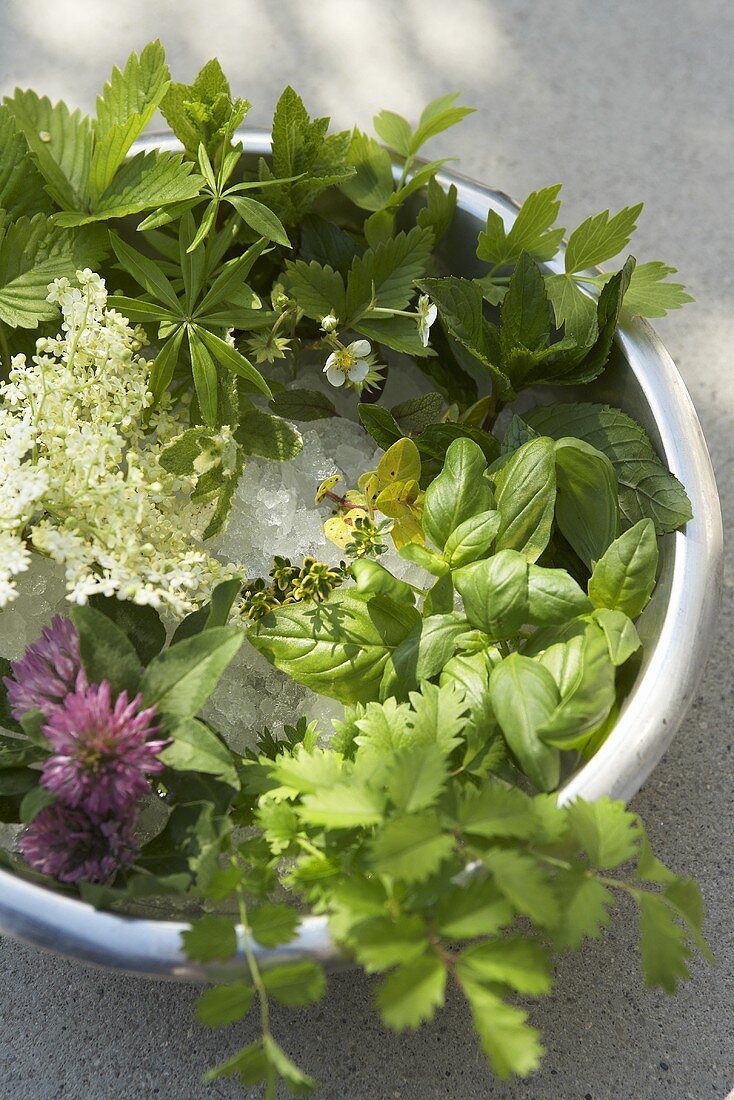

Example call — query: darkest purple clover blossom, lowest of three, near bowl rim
[21,802,135,882]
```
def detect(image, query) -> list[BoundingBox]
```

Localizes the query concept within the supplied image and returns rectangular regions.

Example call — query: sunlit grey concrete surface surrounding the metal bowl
[0,0,734,1100]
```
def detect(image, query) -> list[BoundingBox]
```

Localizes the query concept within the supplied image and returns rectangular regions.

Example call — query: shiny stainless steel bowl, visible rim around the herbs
[0,131,722,981]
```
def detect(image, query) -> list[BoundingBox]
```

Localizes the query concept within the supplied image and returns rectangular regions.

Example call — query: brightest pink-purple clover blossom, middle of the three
[41,680,169,817]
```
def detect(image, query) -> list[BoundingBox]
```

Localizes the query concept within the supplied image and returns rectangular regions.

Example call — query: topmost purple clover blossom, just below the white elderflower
[3,615,87,722]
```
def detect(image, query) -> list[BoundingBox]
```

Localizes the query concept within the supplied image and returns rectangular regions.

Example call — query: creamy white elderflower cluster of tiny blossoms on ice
[0,270,231,615]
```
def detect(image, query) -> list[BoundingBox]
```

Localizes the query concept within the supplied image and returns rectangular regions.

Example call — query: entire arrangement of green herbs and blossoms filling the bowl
[0,43,710,1097]
